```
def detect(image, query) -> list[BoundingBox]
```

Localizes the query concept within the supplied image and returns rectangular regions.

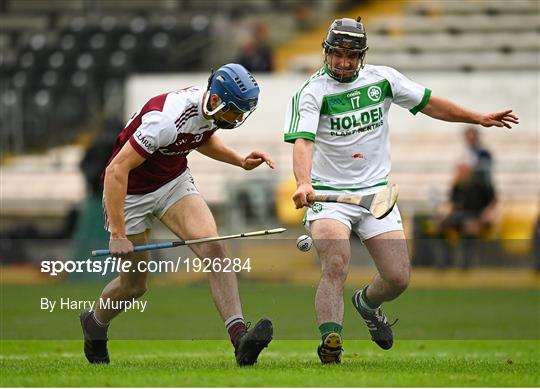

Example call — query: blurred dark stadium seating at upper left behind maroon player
[0,0,334,153]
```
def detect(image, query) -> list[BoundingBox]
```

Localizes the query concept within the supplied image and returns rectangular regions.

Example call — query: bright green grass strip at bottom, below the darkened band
[1,340,540,387]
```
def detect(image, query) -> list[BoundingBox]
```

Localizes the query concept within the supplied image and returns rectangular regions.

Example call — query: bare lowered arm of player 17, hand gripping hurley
[293,138,315,209]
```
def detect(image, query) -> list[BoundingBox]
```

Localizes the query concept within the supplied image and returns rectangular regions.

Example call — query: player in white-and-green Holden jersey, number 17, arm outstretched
[285,18,518,363]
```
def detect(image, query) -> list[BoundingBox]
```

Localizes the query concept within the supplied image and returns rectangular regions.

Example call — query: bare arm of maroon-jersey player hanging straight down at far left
[104,142,145,255]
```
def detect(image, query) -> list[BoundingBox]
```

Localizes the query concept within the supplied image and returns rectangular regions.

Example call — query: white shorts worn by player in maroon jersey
[103,169,199,235]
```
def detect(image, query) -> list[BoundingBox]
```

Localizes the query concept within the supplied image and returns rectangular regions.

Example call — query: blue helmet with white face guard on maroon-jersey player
[203,64,260,129]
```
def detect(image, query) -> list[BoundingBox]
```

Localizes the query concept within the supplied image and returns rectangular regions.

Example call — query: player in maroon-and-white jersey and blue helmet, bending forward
[80,64,274,366]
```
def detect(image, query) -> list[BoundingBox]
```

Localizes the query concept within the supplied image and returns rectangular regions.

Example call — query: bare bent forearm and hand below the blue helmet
[197,135,275,170]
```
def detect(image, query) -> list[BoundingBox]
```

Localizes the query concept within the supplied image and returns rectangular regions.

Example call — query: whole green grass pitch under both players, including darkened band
[0,283,540,387]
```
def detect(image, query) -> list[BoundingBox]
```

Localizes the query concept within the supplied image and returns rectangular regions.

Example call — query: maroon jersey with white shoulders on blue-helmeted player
[107,87,217,194]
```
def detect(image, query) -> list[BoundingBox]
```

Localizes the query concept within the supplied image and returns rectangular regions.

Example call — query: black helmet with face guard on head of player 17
[322,17,368,82]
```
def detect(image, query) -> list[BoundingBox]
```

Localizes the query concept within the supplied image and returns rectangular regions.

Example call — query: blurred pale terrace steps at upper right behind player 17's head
[277,0,540,71]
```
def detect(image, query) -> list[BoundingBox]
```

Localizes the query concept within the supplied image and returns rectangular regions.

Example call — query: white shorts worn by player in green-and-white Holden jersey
[304,199,403,241]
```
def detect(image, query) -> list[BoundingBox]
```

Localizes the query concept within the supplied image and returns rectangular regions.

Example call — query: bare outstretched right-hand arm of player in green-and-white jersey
[421,96,519,128]
